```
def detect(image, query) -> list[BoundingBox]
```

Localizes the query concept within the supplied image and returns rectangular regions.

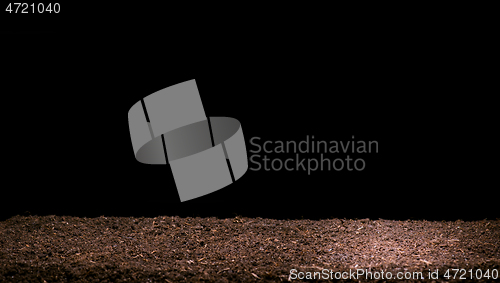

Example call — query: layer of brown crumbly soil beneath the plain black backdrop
[0,216,500,282]
